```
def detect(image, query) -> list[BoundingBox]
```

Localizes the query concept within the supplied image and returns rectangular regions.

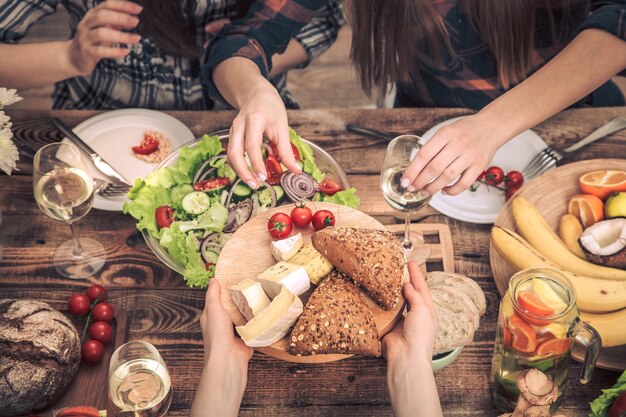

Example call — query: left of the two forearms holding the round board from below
[191,279,253,417]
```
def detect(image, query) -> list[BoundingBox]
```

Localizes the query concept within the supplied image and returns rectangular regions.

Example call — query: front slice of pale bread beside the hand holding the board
[430,287,478,354]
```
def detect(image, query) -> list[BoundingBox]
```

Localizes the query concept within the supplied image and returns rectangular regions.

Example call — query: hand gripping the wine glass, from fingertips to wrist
[402,115,503,195]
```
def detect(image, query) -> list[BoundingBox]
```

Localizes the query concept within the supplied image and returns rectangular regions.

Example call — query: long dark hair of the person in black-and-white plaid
[134,0,255,59]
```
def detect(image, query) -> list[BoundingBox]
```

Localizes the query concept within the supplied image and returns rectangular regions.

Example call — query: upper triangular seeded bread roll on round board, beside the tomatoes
[311,227,405,310]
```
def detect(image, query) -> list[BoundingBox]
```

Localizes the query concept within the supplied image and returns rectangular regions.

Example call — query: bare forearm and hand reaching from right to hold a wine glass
[403,28,626,195]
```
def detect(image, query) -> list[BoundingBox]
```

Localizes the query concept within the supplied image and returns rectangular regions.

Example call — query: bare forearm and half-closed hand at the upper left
[0,0,142,89]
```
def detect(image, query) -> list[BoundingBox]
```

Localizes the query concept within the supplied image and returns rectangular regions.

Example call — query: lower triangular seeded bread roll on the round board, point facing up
[289,270,381,356]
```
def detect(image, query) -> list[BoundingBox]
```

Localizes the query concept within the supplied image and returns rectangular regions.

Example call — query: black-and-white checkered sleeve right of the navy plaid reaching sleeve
[295,0,346,68]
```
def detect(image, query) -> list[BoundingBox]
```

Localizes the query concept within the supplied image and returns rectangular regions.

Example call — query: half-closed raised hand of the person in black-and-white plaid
[69,0,143,75]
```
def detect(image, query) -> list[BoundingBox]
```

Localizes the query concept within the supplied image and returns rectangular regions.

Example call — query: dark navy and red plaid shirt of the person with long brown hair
[203,0,626,109]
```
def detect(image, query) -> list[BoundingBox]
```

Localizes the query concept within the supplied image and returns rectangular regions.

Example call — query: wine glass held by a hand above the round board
[380,135,430,264]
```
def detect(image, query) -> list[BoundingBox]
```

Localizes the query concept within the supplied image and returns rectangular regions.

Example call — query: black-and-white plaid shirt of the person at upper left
[0,0,344,110]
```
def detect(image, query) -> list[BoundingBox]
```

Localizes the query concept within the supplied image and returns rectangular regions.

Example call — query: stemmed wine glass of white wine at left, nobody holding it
[33,142,105,278]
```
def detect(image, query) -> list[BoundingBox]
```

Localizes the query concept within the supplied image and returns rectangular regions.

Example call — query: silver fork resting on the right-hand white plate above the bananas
[522,116,626,179]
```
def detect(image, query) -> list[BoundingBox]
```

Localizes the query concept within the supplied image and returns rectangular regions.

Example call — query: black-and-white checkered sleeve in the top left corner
[0,0,57,43]
